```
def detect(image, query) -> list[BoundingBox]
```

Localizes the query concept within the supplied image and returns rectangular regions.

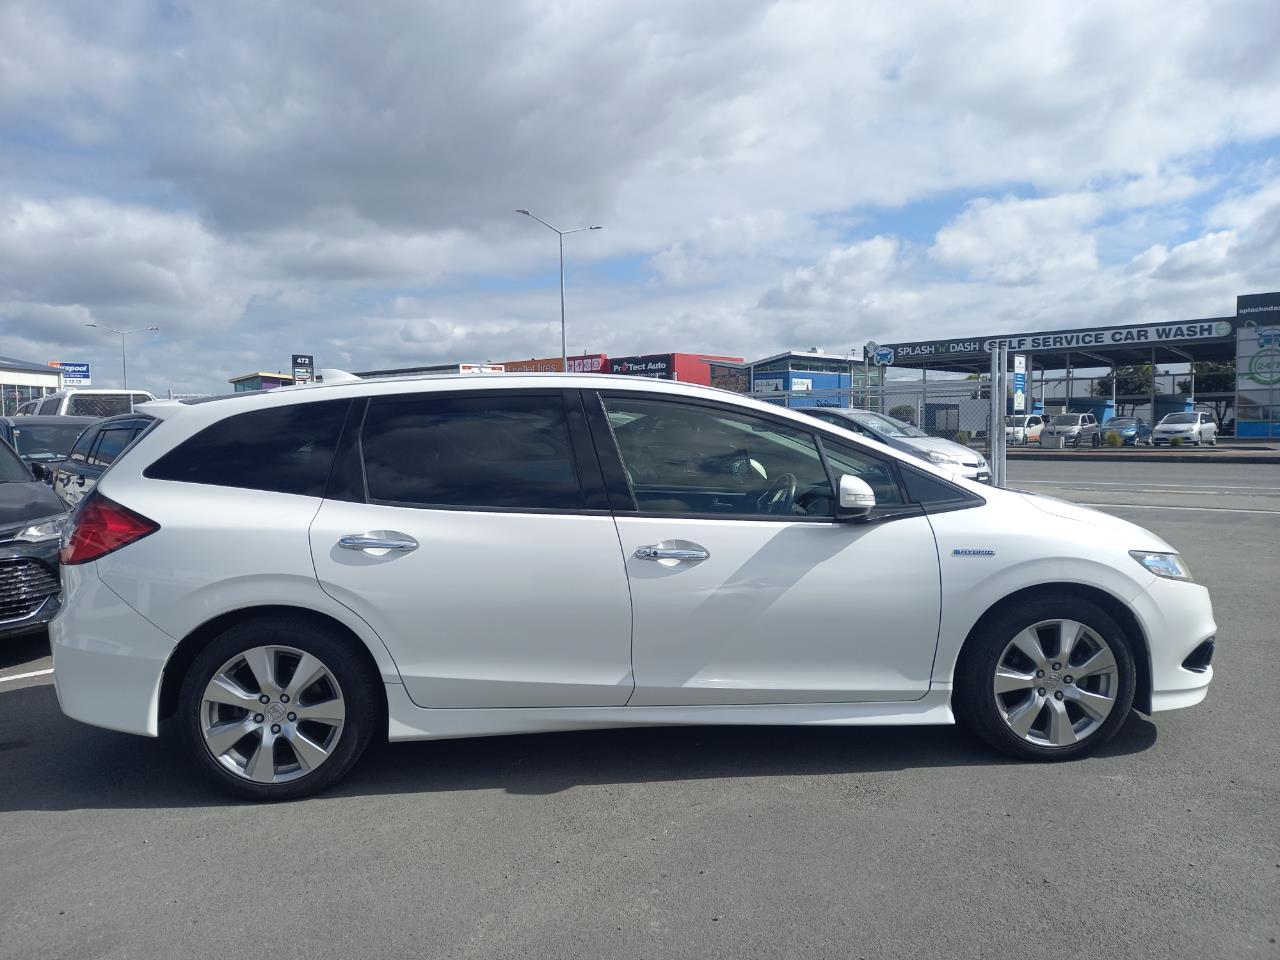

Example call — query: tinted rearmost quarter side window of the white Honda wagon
[143,399,351,497]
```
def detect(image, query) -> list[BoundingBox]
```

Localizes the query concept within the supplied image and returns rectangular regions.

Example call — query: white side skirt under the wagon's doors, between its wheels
[387,682,955,740]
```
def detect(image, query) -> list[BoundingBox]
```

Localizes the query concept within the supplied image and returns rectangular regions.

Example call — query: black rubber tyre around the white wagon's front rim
[952,596,1137,760]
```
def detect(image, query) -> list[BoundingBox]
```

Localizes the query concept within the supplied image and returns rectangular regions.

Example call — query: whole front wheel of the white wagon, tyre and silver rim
[955,598,1135,760]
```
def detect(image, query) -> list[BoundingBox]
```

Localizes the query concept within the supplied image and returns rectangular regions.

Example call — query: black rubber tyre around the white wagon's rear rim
[177,613,385,800]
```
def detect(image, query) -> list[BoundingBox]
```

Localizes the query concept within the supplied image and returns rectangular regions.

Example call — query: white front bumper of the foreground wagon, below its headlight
[1133,579,1217,713]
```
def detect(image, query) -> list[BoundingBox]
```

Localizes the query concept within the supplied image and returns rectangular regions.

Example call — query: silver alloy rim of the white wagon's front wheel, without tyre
[993,620,1120,748]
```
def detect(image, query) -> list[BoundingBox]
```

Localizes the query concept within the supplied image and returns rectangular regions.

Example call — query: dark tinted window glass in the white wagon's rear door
[361,393,582,509]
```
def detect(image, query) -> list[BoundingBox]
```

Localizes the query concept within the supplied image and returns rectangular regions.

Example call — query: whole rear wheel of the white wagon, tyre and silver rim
[178,616,381,800]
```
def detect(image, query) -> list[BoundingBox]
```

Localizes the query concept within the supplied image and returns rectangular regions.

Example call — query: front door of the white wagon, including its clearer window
[588,392,940,705]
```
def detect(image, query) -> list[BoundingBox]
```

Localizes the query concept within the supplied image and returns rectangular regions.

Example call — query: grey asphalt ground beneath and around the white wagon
[0,462,1280,960]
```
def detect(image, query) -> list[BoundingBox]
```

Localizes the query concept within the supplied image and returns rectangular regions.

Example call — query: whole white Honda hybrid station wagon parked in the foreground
[51,374,1215,800]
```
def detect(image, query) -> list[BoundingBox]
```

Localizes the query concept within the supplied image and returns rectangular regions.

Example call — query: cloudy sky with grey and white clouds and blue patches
[0,0,1280,393]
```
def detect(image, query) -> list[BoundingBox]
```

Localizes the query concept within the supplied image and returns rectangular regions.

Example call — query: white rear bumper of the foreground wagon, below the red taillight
[49,563,177,737]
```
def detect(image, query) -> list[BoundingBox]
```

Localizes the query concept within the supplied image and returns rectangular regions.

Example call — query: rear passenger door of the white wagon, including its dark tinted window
[310,389,632,708]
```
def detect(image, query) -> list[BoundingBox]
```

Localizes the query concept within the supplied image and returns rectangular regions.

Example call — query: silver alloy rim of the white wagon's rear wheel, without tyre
[200,645,347,783]
